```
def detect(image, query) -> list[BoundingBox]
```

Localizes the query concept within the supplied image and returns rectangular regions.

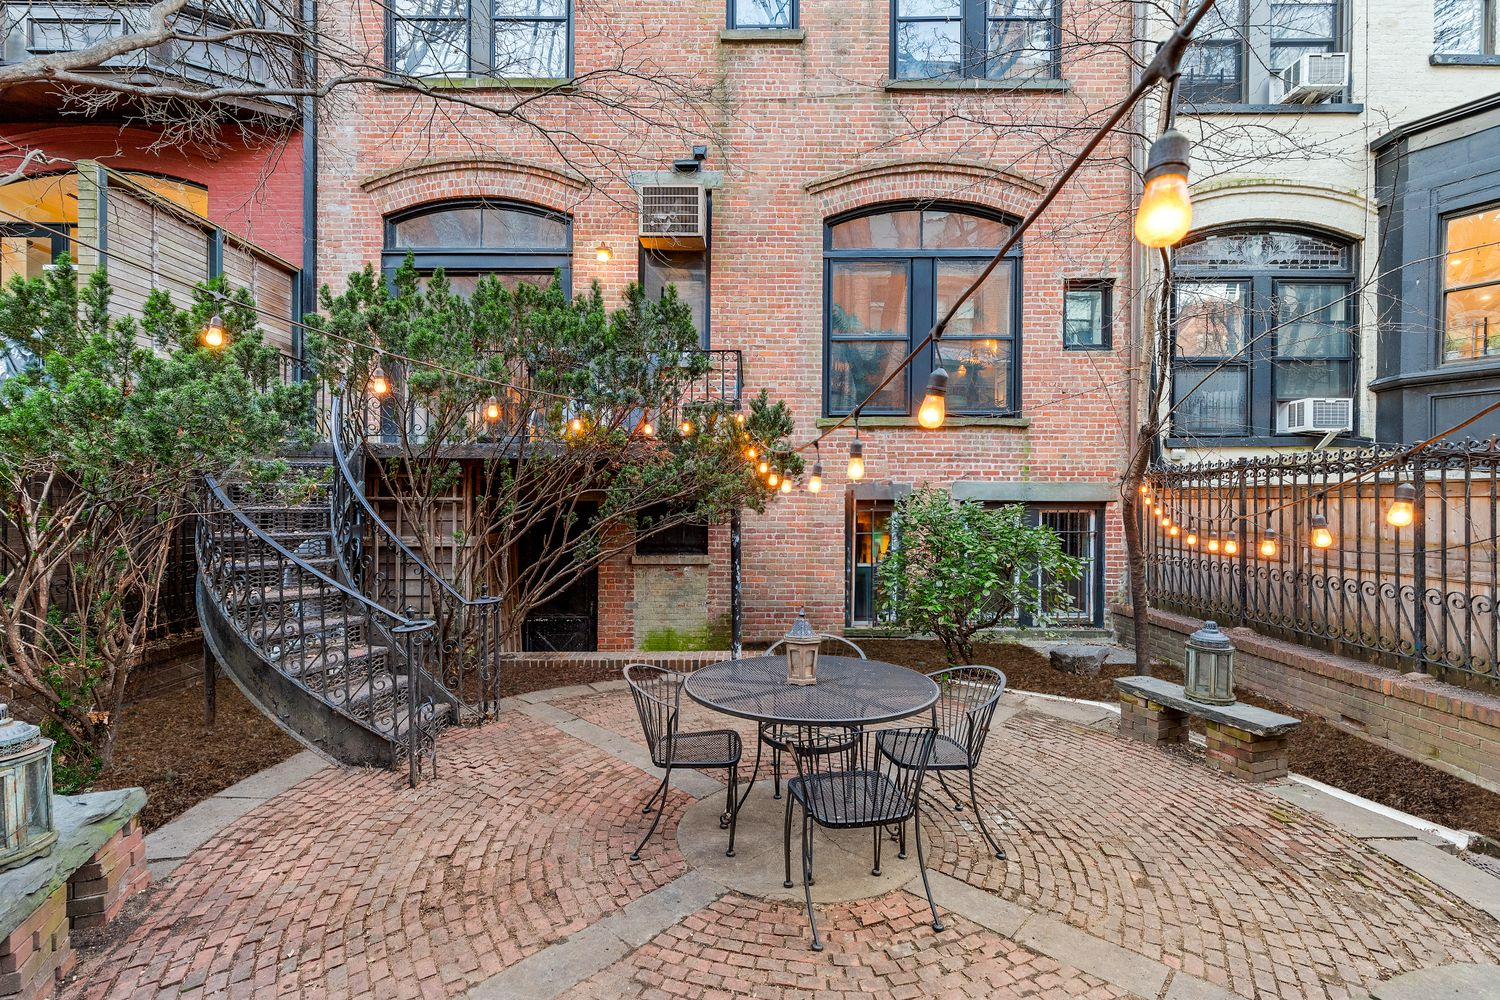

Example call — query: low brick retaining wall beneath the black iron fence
[1110,606,1500,792]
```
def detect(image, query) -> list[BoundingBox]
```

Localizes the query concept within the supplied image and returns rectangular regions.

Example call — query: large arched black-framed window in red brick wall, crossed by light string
[824,204,1022,415]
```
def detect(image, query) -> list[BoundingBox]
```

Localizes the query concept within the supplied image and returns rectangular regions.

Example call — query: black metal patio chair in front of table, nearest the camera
[783,726,942,952]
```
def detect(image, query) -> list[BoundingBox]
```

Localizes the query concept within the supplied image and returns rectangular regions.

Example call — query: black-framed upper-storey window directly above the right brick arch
[891,0,1059,79]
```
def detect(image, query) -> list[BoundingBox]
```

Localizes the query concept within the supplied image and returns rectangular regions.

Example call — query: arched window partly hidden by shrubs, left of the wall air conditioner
[383,201,573,292]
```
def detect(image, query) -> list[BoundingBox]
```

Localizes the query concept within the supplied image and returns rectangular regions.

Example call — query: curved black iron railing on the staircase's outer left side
[197,477,447,783]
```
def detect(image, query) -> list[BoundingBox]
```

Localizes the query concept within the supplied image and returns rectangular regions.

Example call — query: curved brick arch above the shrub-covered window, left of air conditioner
[360,156,590,216]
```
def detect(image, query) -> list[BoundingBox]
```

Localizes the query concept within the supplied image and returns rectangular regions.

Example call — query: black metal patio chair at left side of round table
[624,663,741,861]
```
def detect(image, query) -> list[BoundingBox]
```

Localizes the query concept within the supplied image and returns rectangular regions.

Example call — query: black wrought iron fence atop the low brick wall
[1143,438,1500,679]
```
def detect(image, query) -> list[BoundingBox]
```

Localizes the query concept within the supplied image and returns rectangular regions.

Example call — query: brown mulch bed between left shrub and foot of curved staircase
[92,678,302,832]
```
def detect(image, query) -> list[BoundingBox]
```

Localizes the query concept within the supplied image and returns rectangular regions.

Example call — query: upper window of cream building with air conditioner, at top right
[1178,0,1347,109]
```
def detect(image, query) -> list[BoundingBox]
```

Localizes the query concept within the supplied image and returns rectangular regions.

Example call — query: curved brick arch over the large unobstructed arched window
[804,157,1044,219]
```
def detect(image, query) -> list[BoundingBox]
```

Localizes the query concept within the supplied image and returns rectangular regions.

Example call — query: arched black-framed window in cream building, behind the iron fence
[1172,229,1356,438]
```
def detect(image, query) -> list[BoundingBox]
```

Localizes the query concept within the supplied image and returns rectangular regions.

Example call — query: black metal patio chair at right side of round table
[879,667,1005,861]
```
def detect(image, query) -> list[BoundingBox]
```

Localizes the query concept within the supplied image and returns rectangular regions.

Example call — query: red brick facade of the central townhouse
[318,0,1131,649]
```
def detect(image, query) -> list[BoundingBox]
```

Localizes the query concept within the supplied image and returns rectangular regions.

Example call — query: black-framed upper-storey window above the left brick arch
[387,0,573,79]
